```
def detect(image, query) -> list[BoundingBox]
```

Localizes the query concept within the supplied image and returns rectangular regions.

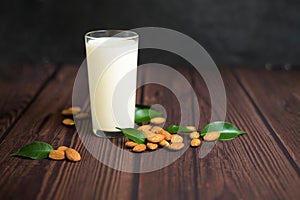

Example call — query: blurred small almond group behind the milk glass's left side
[61,106,89,126]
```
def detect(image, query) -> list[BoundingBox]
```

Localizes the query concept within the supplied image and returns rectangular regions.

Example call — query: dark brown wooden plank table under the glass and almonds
[0,65,300,200]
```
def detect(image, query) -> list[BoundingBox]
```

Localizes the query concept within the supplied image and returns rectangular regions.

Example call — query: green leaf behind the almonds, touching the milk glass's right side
[134,107,162,123]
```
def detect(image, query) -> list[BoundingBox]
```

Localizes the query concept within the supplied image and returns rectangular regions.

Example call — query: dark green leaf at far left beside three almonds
[11,142,53,160]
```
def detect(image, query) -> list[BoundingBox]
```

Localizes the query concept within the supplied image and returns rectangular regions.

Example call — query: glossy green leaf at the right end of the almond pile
[201,121,246,141]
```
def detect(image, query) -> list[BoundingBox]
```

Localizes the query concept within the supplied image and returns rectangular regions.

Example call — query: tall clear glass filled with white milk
[85,30,138,137]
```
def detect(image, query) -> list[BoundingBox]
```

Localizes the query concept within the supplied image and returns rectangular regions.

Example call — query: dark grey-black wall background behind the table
[0,0,300,66]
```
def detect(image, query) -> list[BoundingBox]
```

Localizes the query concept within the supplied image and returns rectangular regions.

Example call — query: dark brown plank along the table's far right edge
[235,69,300,167]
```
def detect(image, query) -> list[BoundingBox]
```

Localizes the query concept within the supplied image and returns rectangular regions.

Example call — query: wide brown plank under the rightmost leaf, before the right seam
[193,70,300,199]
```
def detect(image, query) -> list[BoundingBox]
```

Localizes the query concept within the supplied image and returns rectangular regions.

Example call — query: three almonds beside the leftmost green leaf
[48,146,81,162]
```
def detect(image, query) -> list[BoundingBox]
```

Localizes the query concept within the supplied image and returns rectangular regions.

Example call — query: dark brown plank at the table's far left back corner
[0,64,56,139]
